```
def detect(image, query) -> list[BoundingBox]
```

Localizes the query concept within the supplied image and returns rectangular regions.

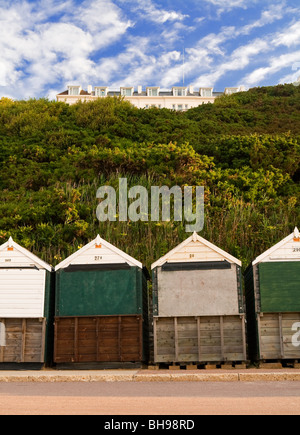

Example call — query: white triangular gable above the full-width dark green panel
[55,234,143,271]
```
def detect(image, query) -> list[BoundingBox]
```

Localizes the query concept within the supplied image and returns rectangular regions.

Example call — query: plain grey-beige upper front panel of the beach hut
[155,265,243,316]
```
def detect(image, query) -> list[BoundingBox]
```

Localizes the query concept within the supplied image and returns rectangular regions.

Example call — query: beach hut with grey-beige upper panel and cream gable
[151,233,246,364]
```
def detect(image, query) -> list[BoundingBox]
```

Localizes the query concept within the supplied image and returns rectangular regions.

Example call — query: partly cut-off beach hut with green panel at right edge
[245,228,300,362]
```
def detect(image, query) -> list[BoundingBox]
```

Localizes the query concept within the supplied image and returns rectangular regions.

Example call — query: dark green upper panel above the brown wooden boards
[55,267,143,316]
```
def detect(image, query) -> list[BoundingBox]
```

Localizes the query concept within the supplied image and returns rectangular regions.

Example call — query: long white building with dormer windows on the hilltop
[56,86,245,111]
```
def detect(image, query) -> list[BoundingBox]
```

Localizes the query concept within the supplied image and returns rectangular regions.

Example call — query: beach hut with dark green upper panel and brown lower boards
[54,235,148,367]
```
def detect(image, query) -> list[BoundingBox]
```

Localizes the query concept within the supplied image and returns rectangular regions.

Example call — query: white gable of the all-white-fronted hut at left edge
[0,237,52,272]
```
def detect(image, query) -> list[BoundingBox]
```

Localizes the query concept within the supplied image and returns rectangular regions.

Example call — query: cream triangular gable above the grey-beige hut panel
[151,232,242,269]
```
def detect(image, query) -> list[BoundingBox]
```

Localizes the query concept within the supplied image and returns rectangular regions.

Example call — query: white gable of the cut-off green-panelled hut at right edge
[252,227,300,266]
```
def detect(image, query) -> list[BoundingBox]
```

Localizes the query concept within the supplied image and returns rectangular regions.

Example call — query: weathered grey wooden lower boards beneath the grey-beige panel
[154,315,247,363]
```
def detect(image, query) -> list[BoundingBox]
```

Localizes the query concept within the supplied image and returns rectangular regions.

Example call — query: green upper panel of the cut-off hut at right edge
[259,261,300,313]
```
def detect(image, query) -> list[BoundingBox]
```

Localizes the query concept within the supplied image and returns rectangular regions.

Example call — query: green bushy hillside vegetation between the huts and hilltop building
[0,85,300,268]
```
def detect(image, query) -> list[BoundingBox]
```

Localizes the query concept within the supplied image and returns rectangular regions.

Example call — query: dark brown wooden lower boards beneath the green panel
[54,316,143,363]
